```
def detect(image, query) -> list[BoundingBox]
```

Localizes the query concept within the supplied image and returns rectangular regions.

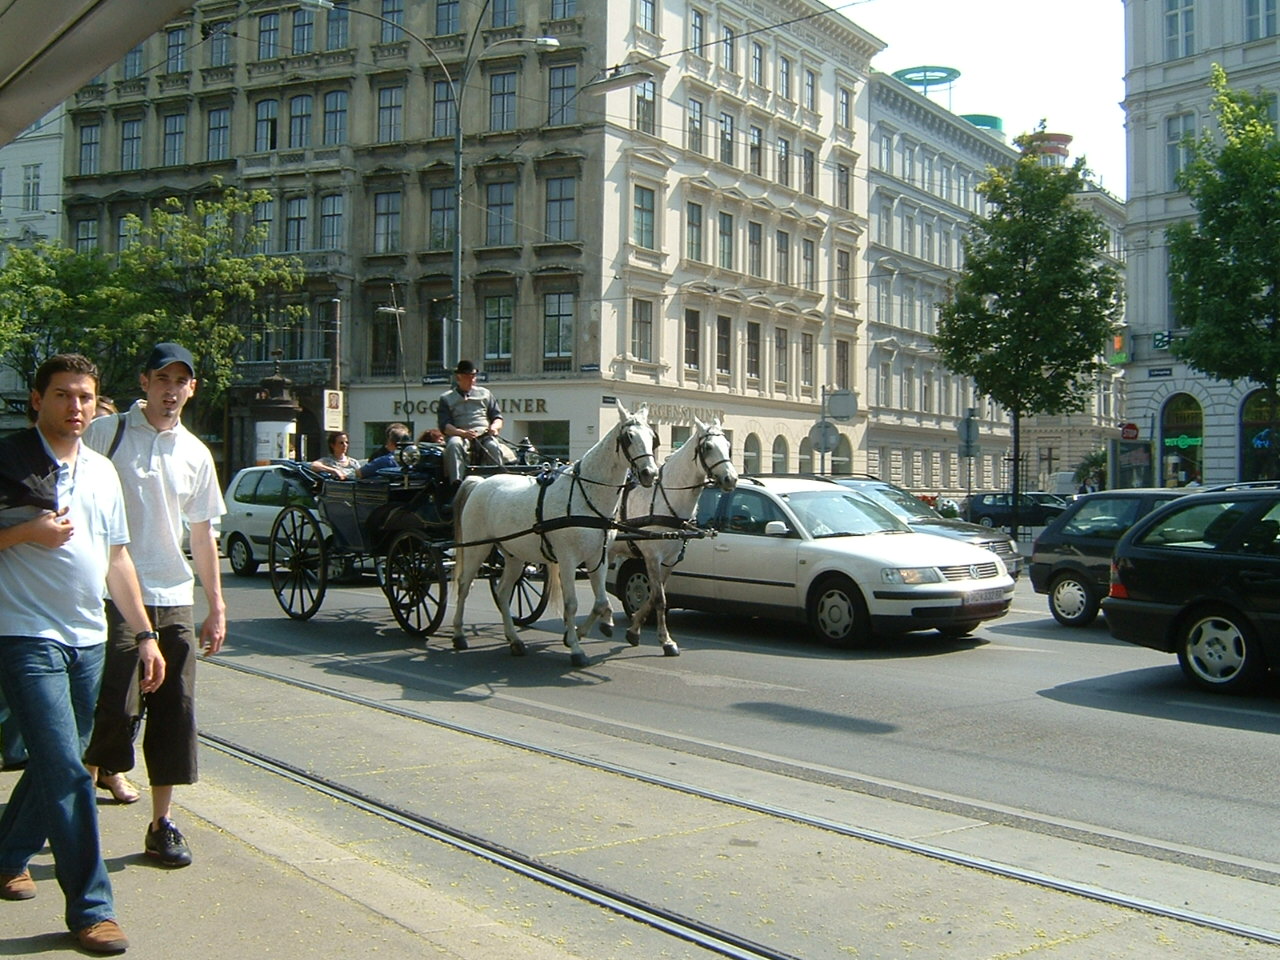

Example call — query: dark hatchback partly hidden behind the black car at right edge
[1028,488,1184,627]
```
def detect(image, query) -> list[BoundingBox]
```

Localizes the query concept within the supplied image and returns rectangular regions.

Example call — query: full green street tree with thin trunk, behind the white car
[933,133,1120,535]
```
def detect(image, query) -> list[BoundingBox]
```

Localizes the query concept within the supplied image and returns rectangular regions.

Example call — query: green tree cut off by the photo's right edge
[1166,64,1280,477]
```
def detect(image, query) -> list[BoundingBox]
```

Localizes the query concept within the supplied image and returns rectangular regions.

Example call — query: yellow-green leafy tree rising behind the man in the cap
[120,184,306,424]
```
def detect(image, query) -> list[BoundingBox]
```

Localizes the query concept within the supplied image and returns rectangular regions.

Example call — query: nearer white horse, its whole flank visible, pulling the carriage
[453,403,658,667]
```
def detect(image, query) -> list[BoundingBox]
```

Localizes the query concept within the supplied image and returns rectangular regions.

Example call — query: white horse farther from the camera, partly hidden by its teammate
[612,417,737,657]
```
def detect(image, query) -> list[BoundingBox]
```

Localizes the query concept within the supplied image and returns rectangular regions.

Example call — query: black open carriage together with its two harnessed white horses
[268,404,737,667]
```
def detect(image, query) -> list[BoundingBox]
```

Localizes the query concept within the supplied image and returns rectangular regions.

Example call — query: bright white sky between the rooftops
[844,0,1126,200]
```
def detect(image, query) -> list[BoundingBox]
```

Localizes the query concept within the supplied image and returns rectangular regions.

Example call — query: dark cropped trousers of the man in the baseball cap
[84,600,197,787]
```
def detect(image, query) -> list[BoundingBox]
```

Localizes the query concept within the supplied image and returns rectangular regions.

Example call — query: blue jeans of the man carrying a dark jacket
[0,636,115,931]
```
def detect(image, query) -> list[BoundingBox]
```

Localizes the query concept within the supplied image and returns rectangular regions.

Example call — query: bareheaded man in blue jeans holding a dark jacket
[0,353,165,954]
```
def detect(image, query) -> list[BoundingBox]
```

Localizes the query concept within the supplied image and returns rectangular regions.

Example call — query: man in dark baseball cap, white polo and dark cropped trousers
[84,343,227,867]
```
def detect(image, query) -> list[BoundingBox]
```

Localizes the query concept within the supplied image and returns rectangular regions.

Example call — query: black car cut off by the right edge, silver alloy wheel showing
[1102,481,1280,692]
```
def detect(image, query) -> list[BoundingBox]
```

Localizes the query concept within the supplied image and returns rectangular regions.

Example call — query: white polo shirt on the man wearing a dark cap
[84,399,227,607]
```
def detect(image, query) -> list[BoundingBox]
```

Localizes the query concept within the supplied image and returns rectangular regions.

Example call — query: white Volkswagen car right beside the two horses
[609,476,1014,645]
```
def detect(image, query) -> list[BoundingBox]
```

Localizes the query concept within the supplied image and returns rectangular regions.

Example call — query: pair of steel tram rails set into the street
[201,660,1280,960]
